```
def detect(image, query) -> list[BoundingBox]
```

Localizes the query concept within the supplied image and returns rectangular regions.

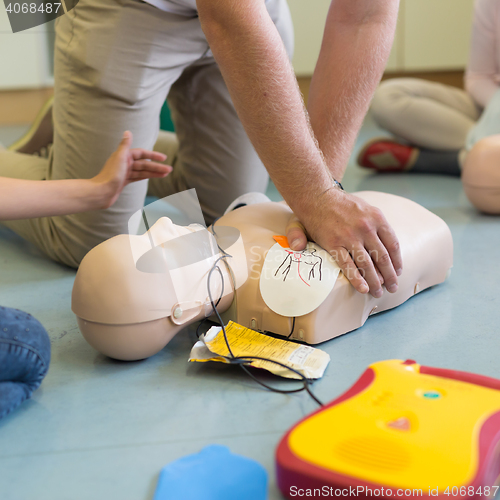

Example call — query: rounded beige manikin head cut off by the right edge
[462,135,500,214]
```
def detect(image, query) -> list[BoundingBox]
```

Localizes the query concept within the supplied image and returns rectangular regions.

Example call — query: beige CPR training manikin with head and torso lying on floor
[72,192,453,360]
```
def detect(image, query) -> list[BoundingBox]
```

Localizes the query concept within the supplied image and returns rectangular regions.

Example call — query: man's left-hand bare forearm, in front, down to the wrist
[198,0,331,219]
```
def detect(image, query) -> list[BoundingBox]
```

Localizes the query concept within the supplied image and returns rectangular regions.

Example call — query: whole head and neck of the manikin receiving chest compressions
[72,217,247,360]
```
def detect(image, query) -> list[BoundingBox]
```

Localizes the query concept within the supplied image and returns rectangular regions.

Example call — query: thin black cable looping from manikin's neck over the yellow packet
[203,232,324,406]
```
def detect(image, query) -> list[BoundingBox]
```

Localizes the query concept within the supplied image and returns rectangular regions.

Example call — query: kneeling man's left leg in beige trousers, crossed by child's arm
[2,0,207,267]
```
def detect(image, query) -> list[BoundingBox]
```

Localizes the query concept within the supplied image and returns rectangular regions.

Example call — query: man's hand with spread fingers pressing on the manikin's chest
[286,188,403,297]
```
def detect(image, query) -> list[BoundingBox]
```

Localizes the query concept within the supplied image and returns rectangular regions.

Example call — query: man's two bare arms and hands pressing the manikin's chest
[197,0,402,297]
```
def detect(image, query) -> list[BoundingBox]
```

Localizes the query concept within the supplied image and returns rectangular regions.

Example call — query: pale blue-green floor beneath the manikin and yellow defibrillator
[0,115,500,500]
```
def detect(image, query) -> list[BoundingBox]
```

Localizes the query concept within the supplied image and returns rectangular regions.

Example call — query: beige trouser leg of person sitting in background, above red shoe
[370,78,480,150]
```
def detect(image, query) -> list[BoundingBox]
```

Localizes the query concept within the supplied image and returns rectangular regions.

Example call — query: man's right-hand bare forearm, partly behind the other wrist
[308,0,399,179]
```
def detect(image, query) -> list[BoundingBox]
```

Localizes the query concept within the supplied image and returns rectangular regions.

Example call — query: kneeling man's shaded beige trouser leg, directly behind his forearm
[150,57,268,224]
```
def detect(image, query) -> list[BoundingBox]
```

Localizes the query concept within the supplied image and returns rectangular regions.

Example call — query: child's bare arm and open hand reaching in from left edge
[0,132,172,220]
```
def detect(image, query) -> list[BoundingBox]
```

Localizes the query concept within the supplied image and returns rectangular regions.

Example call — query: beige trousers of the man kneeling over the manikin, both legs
[0,0,293,267]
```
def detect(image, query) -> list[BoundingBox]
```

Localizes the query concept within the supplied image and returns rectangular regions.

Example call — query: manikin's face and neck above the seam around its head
[73,217,247,324]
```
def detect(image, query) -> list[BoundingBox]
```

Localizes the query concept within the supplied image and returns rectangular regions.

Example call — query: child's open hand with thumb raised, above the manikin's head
[92,132,172,208]
